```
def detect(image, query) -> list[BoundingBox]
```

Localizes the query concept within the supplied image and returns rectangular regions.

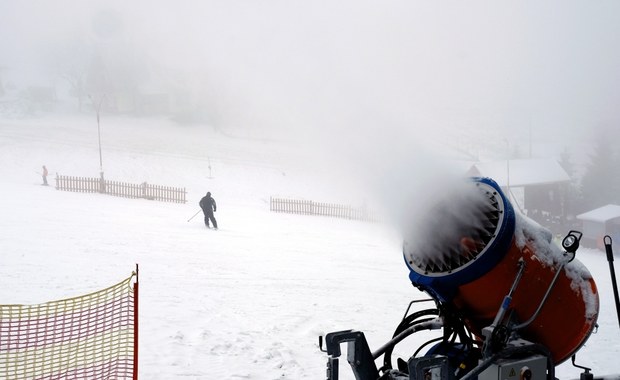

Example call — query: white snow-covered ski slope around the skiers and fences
[0,117,620,379]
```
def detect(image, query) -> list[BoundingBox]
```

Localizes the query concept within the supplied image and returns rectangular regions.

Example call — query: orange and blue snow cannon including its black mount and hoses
[320,178,599,380]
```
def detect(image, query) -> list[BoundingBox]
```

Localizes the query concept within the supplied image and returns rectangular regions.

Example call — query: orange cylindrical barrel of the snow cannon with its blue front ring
[403,178,599,364]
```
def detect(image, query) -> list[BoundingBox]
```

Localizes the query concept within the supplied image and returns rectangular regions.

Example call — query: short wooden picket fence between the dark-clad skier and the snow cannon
[269,197,379,222]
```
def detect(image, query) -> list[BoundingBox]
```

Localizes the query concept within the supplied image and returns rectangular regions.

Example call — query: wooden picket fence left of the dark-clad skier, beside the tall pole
[56,174,187,203]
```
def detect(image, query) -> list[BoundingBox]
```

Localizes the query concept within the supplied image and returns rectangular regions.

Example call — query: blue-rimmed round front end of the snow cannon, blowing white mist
[403,177,515,302]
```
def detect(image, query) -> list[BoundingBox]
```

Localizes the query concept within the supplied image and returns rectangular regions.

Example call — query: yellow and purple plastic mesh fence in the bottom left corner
[0,273,138,380]
